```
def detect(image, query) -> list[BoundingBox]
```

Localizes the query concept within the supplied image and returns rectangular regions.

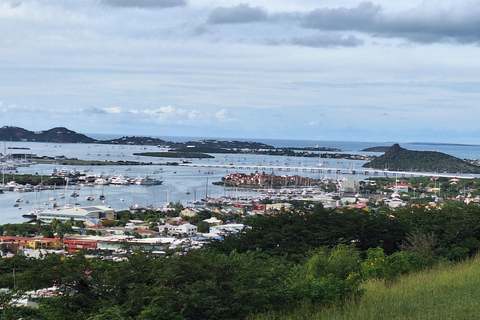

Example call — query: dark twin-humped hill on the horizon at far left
[0,126,97,143]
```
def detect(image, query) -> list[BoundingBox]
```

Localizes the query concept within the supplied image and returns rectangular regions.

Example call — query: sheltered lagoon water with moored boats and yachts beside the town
[0,142,478,224]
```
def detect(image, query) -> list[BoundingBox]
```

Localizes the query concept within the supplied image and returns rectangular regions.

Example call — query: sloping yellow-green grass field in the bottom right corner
[251,256,480,320]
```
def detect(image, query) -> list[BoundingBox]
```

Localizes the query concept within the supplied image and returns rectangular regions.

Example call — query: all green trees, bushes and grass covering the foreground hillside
[0,202,480,320]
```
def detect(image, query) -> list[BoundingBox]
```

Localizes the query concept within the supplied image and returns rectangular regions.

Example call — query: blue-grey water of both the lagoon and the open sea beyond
[0,134,480,224]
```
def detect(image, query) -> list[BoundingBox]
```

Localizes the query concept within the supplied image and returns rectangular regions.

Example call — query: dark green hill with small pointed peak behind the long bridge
[363,144,480,173]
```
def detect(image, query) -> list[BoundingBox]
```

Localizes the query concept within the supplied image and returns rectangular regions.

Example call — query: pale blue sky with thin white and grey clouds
[0,0,480,144]
